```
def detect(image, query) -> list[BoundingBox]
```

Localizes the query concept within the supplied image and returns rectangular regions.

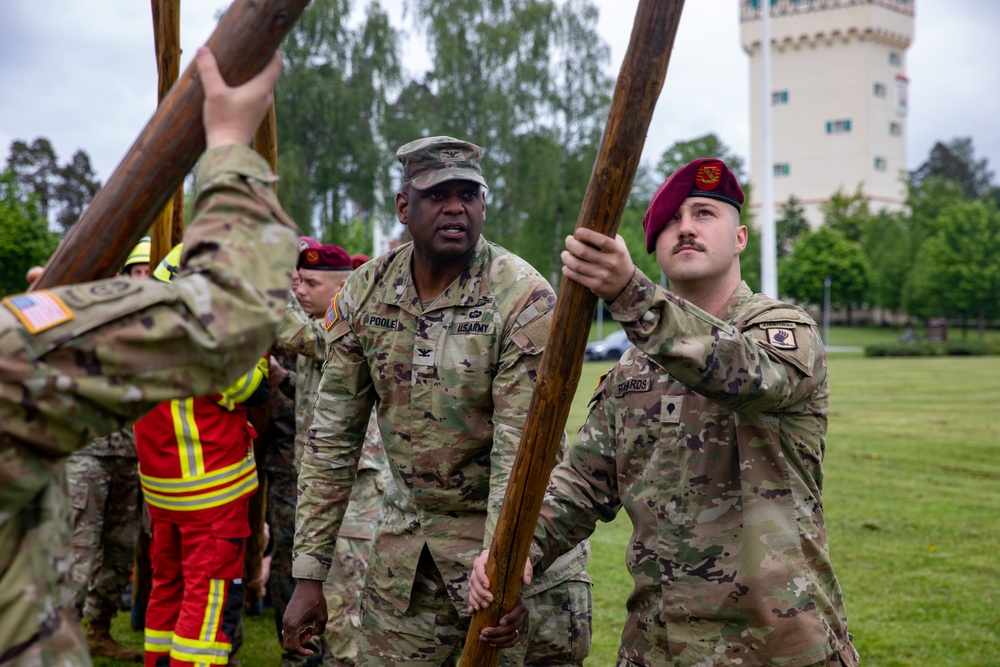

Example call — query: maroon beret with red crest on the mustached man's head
[642,157,743,253]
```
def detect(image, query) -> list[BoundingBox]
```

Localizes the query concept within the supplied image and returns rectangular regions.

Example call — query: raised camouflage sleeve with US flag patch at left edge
[0,146,297,511]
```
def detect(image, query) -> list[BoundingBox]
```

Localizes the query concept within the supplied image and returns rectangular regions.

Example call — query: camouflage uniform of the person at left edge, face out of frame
[0,146,297,665]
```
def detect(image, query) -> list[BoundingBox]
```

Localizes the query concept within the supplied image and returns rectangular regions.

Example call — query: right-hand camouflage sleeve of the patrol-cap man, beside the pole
[483,282,565,547]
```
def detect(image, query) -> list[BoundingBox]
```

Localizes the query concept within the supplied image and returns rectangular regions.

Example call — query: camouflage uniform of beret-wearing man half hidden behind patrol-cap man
[278,298,389,667]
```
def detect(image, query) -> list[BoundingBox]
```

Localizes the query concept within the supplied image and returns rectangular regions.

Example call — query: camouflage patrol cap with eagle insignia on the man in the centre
[396,137,488,190]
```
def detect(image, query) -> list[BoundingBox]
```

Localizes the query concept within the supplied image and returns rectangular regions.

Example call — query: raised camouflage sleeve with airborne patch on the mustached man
[609,270,826,412]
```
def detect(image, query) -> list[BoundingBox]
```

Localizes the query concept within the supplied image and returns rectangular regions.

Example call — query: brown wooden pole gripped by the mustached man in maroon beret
[460,0,684,667]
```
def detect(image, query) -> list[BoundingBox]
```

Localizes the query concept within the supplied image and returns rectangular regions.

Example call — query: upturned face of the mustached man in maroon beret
[656,197,747,290]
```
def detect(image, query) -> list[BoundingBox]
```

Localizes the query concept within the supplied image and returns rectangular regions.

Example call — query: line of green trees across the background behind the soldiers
[0,0,1000,340]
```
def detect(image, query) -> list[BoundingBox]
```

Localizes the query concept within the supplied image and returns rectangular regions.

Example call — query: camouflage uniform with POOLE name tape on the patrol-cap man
[292,238,590,665]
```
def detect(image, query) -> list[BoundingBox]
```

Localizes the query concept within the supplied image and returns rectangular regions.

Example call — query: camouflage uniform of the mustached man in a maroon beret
[531,271,857,667]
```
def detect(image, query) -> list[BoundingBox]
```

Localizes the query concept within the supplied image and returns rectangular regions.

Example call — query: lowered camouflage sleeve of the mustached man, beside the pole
[529,382,621,570]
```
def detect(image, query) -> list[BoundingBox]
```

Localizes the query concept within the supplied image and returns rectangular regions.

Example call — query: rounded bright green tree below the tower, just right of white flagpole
[778,226,871,321]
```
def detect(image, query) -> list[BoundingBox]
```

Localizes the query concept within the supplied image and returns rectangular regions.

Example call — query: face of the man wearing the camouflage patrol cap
[396,181,486,264]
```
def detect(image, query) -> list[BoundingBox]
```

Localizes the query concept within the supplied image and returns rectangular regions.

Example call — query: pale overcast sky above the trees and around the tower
[0,0,1000,181]
